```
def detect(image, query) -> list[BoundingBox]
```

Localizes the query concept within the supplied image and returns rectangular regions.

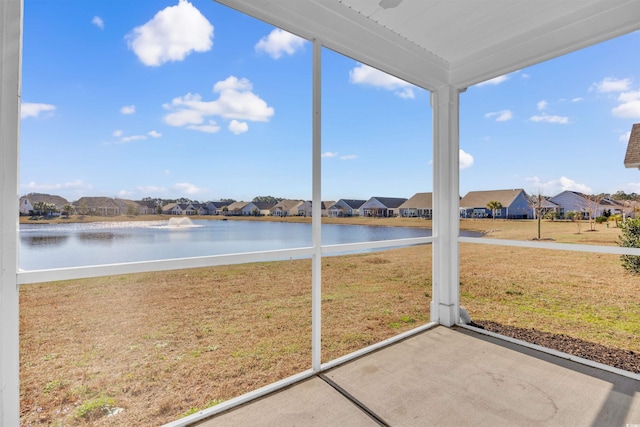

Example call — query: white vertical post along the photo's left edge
[0,0,22,426]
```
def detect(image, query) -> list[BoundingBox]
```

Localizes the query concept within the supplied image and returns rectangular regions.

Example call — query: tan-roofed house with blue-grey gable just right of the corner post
[460,189,533,219]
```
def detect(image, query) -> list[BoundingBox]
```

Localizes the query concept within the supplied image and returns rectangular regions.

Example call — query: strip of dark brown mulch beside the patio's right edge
[474,320,640,374]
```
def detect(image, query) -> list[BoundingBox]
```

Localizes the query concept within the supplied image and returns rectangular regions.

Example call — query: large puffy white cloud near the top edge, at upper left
[125,0,213,66]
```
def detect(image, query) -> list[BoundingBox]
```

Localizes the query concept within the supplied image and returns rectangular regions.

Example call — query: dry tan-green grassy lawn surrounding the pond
[20,216,640,426]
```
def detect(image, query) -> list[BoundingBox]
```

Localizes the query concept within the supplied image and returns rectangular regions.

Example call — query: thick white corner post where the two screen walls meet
[431,86,460,326]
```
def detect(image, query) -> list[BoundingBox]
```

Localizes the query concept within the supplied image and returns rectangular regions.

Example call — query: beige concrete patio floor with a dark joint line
[198,326,640,427]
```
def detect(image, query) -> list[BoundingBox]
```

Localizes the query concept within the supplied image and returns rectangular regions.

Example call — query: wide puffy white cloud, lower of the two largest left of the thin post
[163,76,274,132]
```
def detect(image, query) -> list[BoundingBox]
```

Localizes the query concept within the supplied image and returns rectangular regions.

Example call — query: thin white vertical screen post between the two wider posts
[311,40,322,371]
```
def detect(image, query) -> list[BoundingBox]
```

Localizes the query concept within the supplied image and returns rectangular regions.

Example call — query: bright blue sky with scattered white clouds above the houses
[20,0,640,201]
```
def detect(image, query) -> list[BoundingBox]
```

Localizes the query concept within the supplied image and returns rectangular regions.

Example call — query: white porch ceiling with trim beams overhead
[218,0,640,89]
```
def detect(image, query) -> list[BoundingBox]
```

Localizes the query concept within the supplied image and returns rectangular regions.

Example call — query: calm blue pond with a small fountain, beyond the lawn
[19,218,480,270]
